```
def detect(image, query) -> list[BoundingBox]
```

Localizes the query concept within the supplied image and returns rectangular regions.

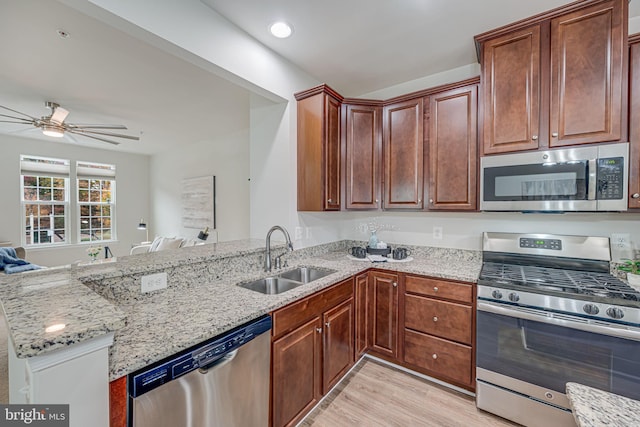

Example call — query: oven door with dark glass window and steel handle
[476,300,640,406]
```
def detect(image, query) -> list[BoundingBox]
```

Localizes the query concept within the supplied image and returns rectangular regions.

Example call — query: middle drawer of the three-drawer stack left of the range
[404,295,472,344]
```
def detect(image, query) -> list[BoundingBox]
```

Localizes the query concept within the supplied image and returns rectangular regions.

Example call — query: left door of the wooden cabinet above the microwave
[481,25,541,154]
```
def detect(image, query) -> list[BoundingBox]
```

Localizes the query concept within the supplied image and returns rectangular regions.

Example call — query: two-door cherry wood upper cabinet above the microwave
[476,0,628,154]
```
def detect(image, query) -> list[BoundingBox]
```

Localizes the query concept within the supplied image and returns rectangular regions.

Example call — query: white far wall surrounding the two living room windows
[0,135,149,266]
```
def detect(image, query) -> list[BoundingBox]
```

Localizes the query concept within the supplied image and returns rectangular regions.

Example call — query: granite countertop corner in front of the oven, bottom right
[566,383,640,427]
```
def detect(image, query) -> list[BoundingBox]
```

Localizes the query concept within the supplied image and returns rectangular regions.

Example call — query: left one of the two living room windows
[20,156,69,245]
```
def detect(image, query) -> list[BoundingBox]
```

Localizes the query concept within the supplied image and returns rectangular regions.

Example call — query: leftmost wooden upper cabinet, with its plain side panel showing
[295,85,342,211]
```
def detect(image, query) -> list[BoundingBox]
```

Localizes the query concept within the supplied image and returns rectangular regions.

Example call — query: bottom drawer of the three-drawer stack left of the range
[404,330,471,384]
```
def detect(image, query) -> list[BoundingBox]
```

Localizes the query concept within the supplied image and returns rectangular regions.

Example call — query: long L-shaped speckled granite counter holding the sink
[0,240,482,380]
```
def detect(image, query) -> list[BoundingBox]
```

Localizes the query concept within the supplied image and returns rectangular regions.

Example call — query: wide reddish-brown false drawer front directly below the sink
[271,278,353,337]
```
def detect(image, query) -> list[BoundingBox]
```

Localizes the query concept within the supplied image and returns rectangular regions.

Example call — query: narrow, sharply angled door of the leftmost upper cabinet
[324,96,340,211]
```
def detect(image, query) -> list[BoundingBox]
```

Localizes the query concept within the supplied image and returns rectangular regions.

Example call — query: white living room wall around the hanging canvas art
[149,129,249,242]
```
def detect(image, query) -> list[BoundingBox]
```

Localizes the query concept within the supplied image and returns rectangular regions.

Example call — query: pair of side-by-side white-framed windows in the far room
[20,155,116,246]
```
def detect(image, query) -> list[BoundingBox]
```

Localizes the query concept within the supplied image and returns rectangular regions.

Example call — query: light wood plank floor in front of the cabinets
[299,358,517,427]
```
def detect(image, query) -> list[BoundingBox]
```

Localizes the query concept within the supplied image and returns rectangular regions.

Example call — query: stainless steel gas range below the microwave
[476,233,640,426]
